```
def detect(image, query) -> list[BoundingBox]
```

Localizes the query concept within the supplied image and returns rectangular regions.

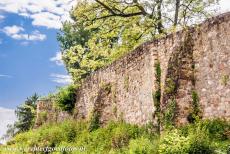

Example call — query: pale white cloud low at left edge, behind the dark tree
[0,107,16,143]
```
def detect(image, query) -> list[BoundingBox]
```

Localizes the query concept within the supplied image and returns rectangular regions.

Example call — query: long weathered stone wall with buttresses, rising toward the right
[36,13,230,125]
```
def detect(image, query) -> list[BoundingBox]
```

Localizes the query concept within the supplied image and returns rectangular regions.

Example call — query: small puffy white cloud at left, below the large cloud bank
[1,25,46,41]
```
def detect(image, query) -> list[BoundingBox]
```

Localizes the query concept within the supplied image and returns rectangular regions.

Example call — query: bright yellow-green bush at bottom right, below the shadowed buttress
[159,121,219,154]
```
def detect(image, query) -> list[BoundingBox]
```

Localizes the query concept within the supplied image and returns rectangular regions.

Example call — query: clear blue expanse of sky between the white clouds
[0,14,66,108]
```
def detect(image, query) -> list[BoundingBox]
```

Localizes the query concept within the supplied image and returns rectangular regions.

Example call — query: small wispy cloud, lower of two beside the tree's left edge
[50,74,73,84]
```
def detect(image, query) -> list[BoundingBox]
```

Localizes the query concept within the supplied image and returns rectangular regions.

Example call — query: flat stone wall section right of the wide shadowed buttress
[194,13,230,119]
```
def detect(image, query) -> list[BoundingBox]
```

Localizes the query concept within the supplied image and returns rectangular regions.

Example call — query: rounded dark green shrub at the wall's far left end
[55,85,77,113]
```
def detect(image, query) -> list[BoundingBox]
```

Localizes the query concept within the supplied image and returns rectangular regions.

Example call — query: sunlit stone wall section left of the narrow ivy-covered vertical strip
[76,43,156,124]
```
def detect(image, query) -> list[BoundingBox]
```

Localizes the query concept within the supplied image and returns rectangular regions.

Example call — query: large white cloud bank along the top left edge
[0,0,77,29]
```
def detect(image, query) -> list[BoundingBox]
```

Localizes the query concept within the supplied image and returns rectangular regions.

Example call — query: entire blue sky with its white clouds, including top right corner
[0,0,230,143]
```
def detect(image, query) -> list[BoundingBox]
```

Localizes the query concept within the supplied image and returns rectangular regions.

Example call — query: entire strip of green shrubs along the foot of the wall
[0,119,230,154]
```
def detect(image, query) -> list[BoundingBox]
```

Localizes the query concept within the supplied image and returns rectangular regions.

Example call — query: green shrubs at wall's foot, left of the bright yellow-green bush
[3,121,152,154]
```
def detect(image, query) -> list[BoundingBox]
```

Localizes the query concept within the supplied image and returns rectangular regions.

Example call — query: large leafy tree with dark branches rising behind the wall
[58,0,218,83]
